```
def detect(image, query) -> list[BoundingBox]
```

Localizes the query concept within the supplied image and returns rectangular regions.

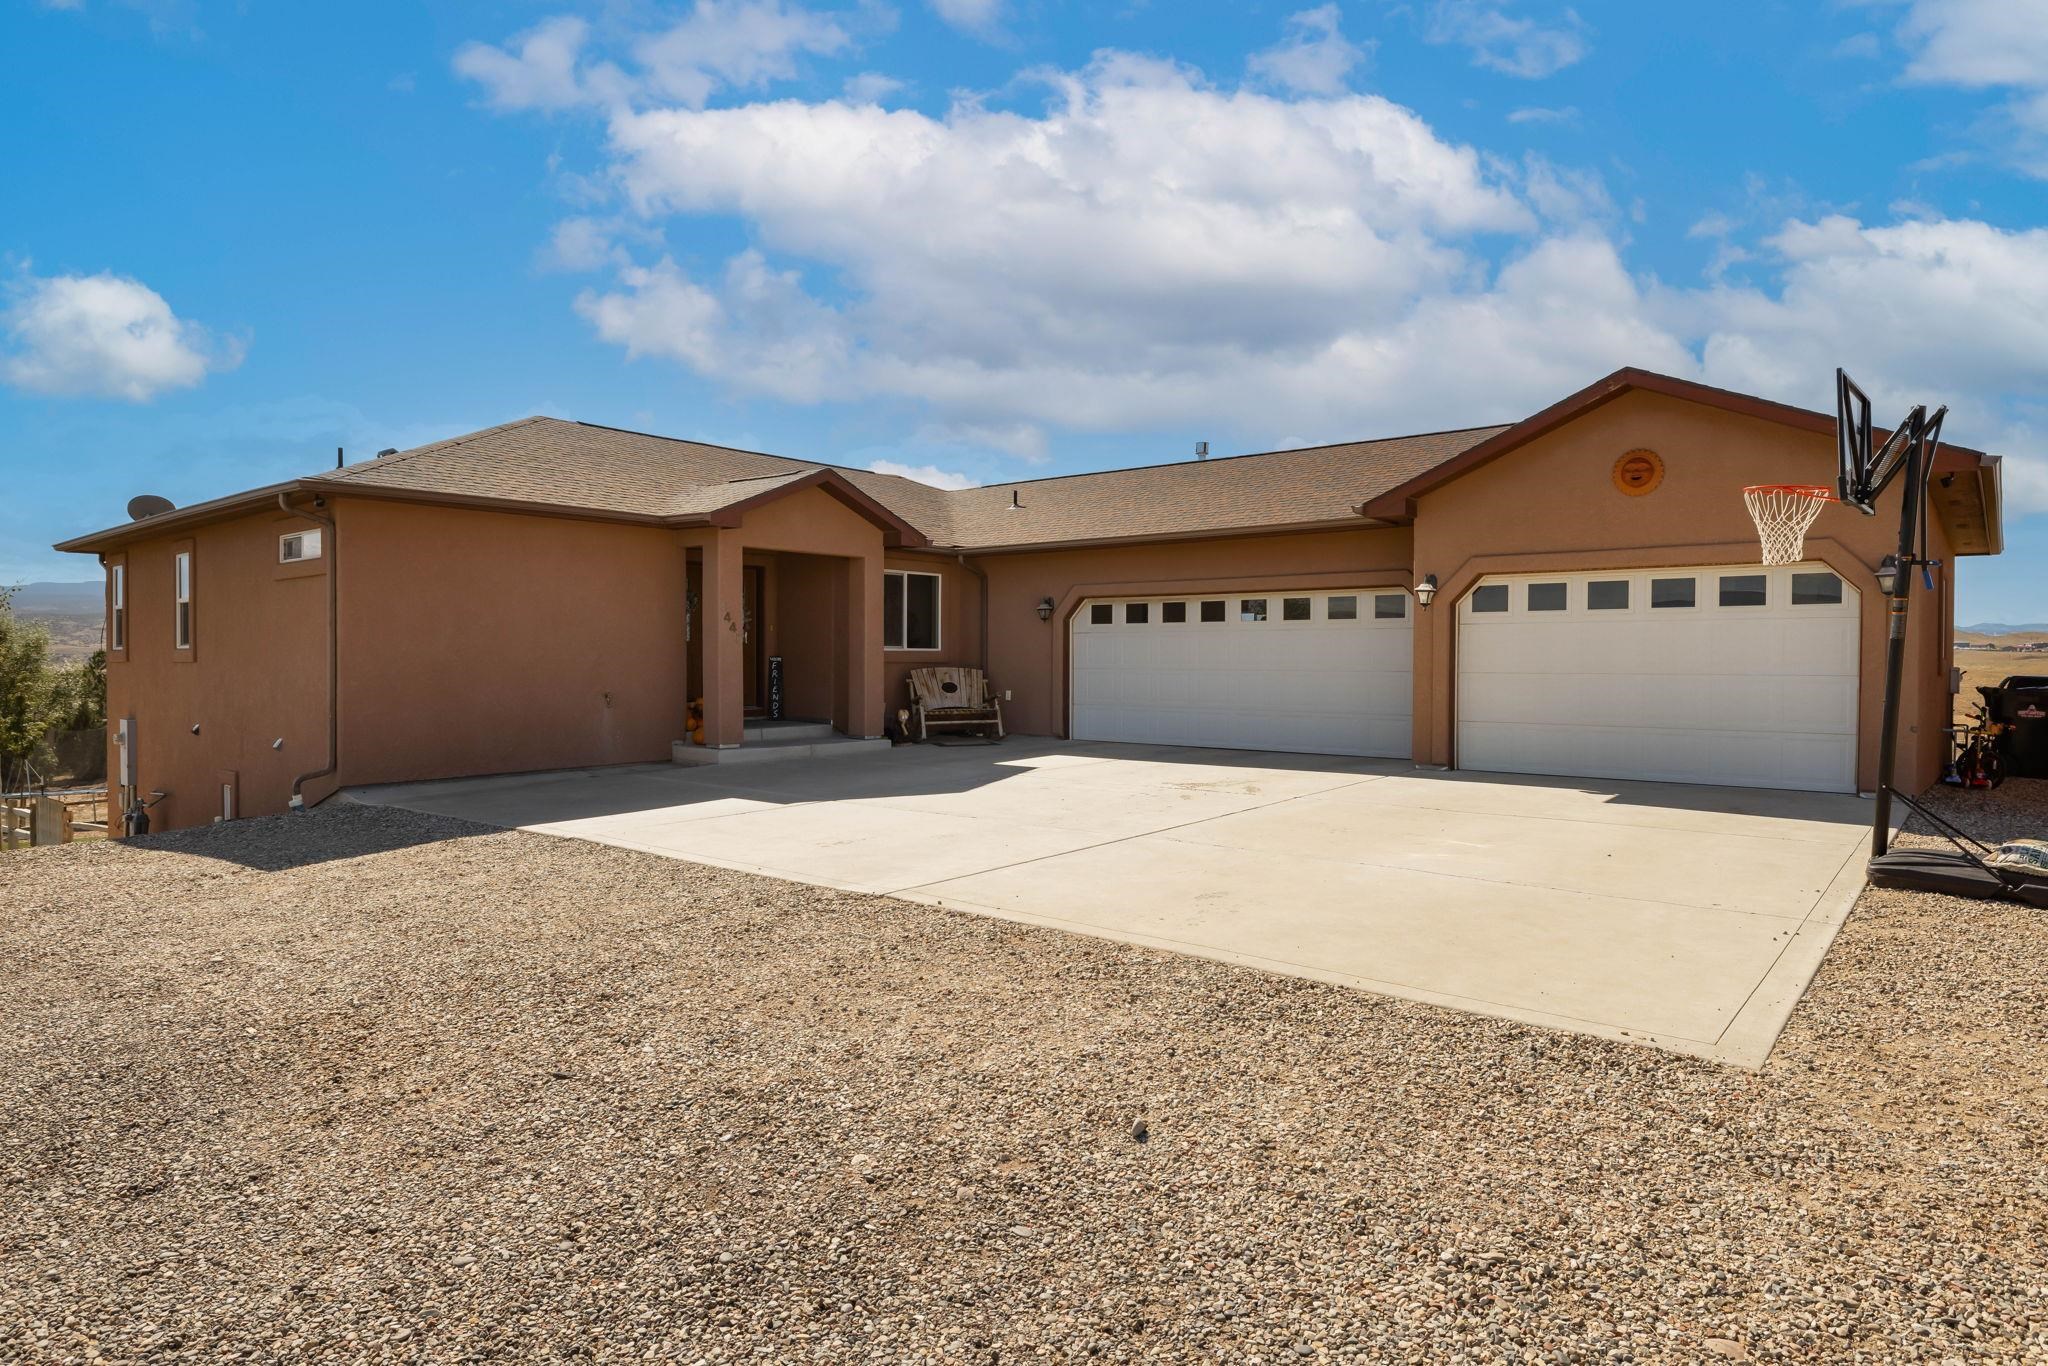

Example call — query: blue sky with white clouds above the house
[0,0,2048,621]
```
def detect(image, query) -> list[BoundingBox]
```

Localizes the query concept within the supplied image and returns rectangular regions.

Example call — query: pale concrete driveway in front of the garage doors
[350,739,1870,1067]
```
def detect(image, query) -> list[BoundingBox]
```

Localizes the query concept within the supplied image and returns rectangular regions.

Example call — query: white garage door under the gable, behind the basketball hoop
[1458,565,1858,793]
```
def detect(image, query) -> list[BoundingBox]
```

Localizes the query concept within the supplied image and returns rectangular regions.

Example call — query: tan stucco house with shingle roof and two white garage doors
[59,371,2001,829]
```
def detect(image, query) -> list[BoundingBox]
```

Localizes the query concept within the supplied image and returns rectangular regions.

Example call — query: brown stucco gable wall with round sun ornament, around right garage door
[1413,393,1954,791]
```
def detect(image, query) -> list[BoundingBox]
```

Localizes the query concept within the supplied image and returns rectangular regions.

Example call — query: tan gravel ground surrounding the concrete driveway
[0,782,2048,1362]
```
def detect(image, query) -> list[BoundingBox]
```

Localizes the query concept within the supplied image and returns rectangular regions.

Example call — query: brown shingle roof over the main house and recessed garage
[322,418,1501,549]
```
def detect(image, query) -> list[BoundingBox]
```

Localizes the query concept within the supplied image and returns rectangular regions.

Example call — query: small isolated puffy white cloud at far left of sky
[0,272,242,403]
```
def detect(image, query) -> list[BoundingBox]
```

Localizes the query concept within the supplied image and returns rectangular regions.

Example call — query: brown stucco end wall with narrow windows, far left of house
[106,501,328,829]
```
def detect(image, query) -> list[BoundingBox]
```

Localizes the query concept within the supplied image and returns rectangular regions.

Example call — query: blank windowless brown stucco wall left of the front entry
[336,498,686,782]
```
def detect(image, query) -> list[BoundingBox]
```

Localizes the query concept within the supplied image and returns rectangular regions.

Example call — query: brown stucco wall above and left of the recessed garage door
[975,526,1411,735]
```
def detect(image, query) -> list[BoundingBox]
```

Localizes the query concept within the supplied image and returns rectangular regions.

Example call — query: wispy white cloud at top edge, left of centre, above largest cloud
[455,0,852,111]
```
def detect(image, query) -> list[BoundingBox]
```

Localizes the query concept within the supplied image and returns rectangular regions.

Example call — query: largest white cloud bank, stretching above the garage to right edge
[468,36,2048,508]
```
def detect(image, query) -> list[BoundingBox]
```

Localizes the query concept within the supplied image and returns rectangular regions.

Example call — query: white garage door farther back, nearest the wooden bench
[1069,588,1413,758]
